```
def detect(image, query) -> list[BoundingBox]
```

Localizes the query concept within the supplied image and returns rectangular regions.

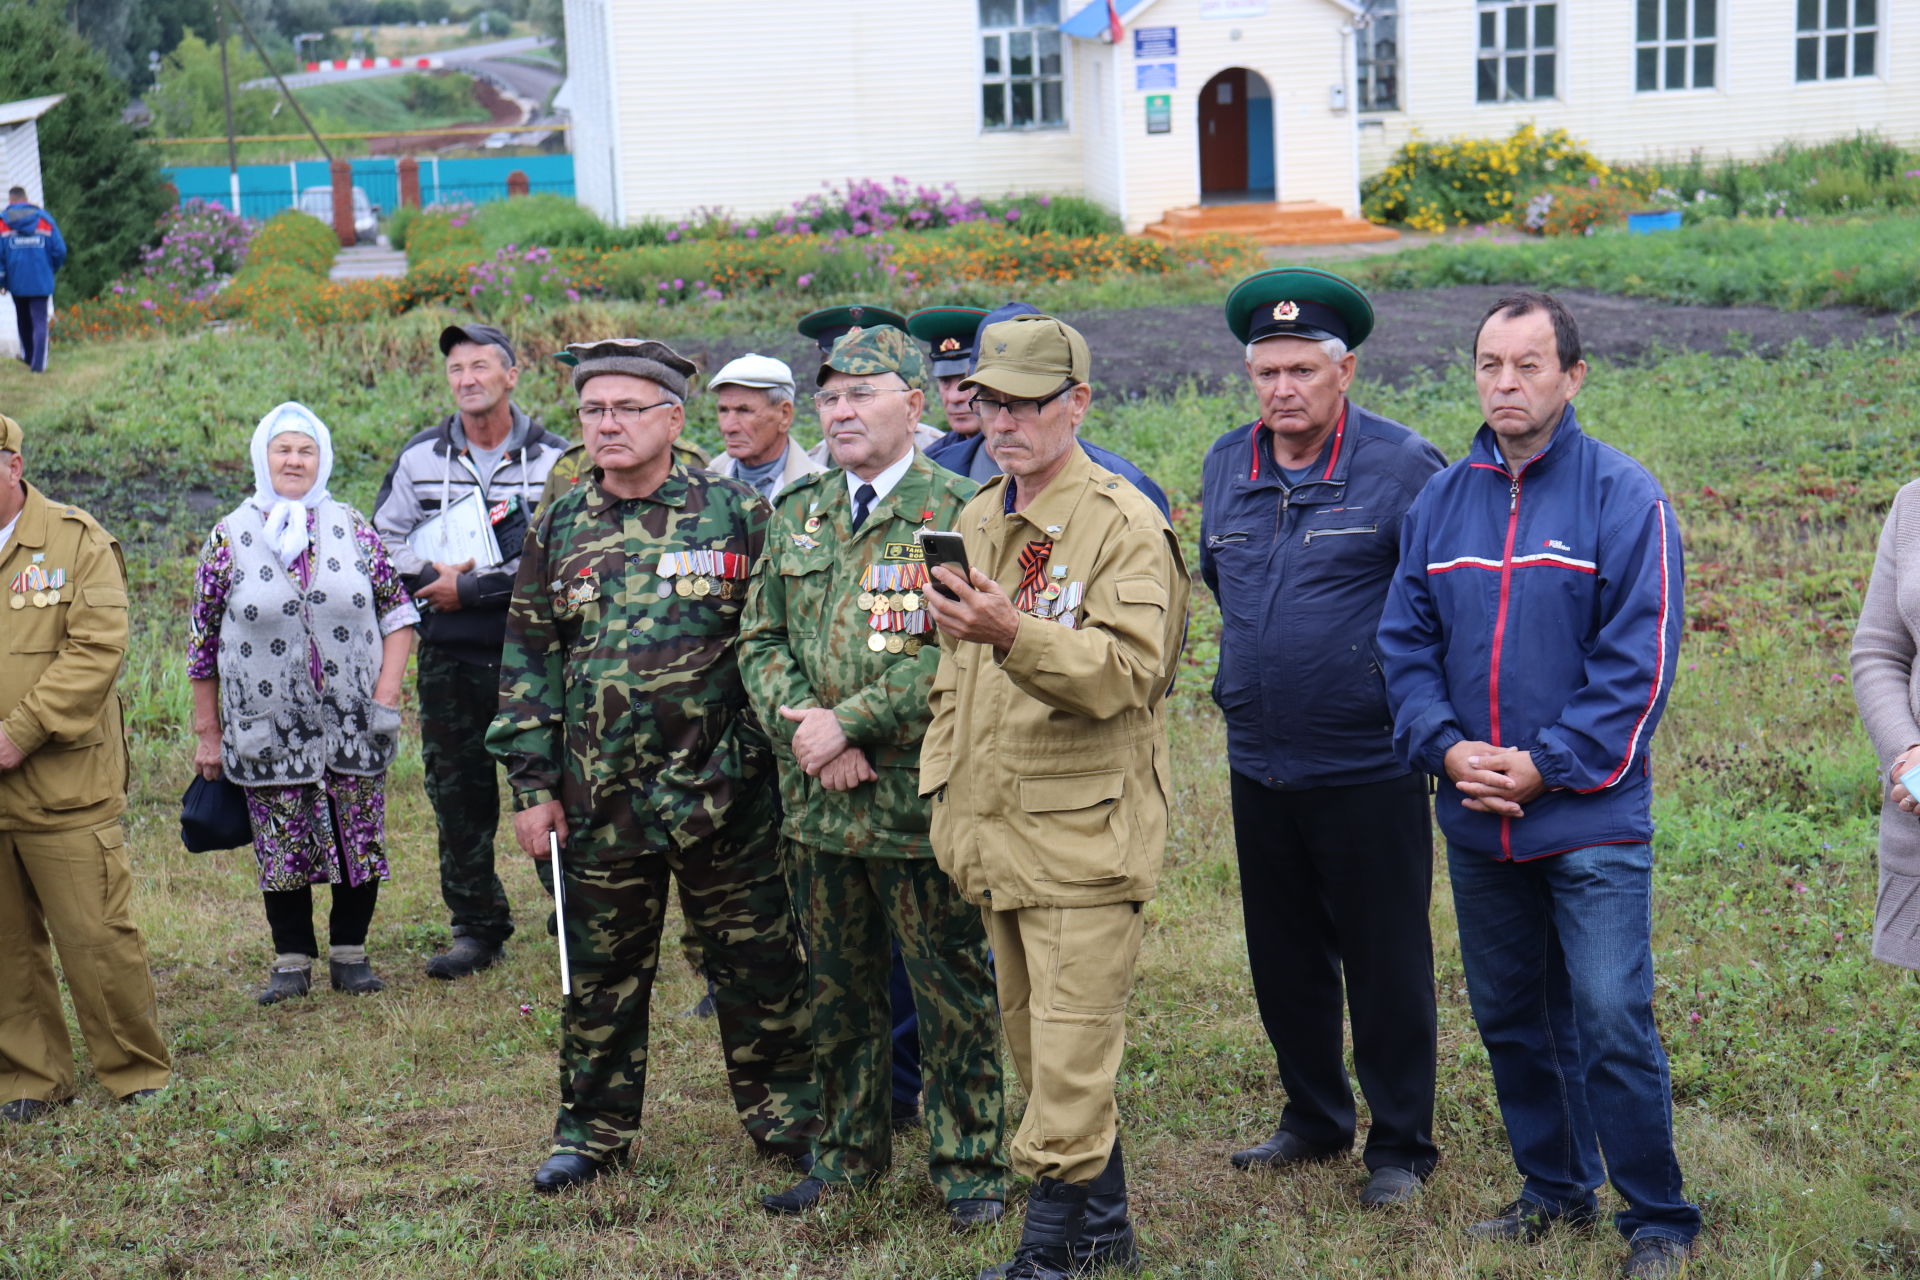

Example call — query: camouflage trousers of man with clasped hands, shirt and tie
[783,841,1006,1199]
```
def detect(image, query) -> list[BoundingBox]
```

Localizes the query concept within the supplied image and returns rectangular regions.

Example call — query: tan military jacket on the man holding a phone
[920,449,1192,910]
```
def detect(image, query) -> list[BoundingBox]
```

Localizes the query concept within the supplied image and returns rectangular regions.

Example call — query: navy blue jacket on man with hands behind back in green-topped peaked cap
[1200,401,1446,789]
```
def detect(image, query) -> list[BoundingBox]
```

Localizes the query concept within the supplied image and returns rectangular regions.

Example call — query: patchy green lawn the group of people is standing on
[0,315,1920,1280]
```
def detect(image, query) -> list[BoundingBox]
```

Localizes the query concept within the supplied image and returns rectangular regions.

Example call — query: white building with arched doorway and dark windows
[566,0,1920,230]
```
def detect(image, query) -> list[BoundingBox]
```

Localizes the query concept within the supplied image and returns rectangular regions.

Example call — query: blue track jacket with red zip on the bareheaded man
[1379,405,1682,860]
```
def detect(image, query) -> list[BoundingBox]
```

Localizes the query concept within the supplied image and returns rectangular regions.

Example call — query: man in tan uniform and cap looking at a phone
[920,315,1190,1280]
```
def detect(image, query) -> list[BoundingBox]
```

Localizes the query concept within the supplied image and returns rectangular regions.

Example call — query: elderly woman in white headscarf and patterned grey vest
[186,403,419,1004]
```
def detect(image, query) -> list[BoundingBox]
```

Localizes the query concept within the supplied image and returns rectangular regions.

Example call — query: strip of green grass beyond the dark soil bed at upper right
[1346,215,1920,313]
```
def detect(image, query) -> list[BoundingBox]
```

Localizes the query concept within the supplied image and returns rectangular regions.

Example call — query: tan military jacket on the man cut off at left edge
[0,486,127,831]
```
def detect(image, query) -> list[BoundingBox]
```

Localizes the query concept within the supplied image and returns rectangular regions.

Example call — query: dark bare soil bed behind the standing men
[676,284,1907,395]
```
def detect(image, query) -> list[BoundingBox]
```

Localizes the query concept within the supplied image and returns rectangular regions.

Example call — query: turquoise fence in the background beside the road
[161,155,574,219]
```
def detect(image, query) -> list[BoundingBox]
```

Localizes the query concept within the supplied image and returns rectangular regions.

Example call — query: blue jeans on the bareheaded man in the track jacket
[1448,844,1699,1244]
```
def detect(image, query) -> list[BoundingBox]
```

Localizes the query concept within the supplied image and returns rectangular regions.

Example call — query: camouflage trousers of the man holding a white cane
[553,835,820,1159]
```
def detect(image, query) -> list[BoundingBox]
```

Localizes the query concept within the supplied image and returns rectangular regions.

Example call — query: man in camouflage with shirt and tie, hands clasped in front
[741,326,1006,1228]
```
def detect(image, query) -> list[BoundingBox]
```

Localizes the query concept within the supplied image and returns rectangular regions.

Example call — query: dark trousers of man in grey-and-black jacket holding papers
[419,645,513,944]
